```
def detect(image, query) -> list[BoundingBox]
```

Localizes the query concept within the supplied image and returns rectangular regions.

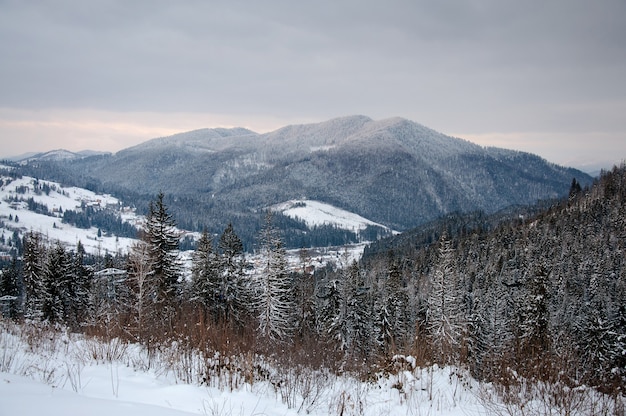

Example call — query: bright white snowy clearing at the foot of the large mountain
[270,200,388,232]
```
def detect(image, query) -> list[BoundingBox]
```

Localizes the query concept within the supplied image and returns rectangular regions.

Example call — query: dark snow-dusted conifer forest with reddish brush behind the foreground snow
[0,166,626,412]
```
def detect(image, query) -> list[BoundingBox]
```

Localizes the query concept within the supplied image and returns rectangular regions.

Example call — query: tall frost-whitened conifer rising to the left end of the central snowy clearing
[255,212,294,341]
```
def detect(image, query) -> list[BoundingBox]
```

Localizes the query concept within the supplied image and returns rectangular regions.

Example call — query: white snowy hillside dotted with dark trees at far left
[0,167,141,254]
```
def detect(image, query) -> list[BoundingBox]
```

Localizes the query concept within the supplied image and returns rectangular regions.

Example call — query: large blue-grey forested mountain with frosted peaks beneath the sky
[15,116,592,236]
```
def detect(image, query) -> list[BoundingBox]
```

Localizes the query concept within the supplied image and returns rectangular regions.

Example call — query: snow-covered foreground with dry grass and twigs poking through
[0,321,624,416]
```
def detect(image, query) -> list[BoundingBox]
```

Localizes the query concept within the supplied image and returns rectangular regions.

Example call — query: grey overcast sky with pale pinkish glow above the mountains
[0,0,626,171]
